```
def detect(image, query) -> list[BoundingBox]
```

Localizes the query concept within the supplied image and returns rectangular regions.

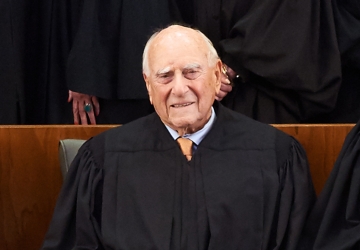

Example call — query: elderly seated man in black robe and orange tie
[43,25,314,250]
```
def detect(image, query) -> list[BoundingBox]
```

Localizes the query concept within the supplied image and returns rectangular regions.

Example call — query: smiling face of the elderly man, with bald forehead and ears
[144,27,221,134]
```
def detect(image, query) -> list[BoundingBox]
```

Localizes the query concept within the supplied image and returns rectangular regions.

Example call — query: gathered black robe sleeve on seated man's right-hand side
[269,139,316,250]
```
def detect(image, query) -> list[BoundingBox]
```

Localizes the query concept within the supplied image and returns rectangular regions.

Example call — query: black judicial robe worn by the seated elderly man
[42,105,314,250]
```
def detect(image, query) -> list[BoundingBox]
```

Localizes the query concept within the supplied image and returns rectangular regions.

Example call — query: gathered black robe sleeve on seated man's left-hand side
[41,143,103,250]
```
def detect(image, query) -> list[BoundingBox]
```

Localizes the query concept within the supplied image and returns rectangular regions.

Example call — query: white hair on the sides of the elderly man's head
[142,26,219,76]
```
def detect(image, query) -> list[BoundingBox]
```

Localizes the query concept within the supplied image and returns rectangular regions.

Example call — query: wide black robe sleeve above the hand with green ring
[67,0,177,99]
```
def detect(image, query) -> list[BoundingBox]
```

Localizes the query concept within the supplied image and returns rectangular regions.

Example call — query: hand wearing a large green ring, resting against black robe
[68,90,100,125]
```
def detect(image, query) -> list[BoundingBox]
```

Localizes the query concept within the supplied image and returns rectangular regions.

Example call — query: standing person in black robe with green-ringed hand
[64,0,180,124]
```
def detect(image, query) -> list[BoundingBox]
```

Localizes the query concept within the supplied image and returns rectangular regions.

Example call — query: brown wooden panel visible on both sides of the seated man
[0,124,354,250]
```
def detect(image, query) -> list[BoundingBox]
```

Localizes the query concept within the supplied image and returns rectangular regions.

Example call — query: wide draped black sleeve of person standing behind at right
[220,0,341,123]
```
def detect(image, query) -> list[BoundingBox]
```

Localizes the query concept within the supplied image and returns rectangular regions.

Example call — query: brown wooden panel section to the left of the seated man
[0,126,114,250]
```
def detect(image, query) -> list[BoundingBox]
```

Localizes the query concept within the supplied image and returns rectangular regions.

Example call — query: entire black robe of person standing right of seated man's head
[180,0,344,123]
